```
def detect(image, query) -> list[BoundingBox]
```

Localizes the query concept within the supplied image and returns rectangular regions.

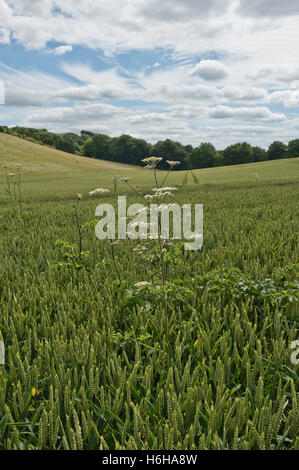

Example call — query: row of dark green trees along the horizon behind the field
[0,126,299,170]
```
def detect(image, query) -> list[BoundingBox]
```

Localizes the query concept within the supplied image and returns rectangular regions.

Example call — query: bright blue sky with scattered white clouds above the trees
[0,0,299,149]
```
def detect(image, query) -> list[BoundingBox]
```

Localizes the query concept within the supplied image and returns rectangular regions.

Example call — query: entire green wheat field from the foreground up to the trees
[0,135,299,450]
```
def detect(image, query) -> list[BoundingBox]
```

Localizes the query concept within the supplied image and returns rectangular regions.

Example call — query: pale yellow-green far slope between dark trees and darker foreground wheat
[0,134,299,199]
